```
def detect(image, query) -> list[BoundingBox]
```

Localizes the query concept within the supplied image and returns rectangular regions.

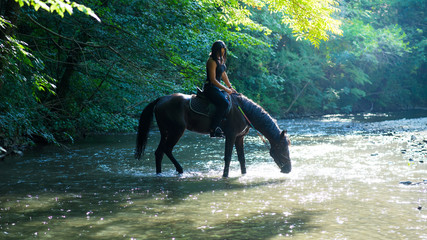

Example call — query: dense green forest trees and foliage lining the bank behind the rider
[0,0,427,150]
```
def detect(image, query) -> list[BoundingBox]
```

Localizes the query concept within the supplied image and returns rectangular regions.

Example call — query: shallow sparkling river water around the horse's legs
[0,113,427,239]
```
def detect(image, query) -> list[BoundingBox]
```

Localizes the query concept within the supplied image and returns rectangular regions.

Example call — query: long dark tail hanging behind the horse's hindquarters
[135,98,160,159]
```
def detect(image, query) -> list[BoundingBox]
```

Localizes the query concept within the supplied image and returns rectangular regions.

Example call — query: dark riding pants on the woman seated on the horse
[203,83,228,130]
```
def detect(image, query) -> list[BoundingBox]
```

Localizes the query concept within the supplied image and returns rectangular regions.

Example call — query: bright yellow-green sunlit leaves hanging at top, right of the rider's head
[200,0,342,47]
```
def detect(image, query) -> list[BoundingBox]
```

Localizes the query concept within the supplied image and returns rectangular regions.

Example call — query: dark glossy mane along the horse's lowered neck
[233,93,280,140]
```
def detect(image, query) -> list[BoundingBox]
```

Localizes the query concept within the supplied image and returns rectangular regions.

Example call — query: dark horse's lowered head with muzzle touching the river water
[270,130,292,173]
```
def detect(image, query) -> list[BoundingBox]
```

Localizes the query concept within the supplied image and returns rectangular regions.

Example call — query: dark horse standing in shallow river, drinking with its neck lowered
[135,93,291,177]
